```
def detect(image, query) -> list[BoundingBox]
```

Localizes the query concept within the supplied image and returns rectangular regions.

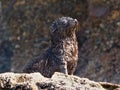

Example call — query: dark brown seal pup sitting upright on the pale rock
[23,17,78,77]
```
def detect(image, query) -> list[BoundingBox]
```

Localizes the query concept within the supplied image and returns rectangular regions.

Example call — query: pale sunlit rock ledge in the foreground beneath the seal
[0,72,120,90]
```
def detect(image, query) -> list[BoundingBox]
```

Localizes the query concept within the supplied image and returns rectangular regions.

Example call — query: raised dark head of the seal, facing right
[50,17,78,38]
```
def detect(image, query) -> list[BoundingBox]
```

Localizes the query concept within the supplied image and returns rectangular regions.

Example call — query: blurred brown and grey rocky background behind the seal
[0,0,120,84]
